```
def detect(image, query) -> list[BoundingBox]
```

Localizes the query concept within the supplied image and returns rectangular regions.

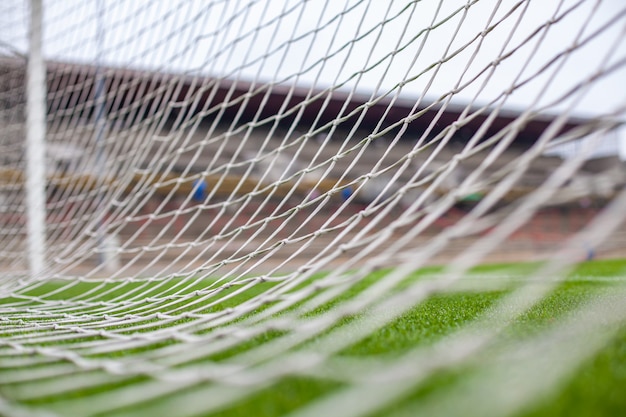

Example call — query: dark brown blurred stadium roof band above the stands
[0,59,589,145]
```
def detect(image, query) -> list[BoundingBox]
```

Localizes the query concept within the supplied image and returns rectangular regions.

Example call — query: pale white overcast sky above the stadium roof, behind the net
[0,0,626,158]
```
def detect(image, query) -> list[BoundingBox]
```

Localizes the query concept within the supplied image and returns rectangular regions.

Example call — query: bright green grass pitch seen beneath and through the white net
[0,260,626,417]
